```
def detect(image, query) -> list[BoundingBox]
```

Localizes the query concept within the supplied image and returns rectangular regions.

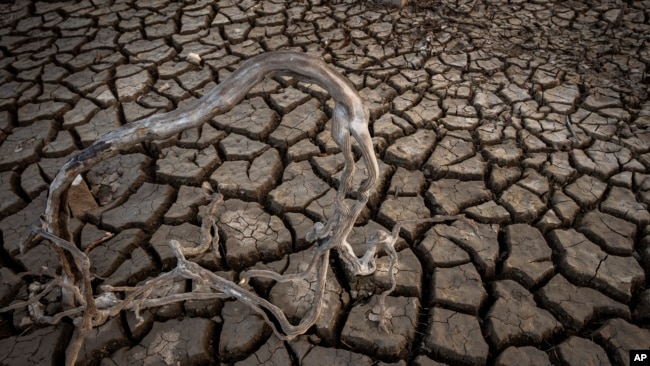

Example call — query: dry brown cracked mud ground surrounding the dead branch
[0,0,650,366]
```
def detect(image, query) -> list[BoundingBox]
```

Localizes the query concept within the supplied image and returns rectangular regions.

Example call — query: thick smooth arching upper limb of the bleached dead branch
[44,52,379,238]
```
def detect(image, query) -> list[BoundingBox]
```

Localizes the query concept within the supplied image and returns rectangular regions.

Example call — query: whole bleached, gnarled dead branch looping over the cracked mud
[6,52,379,365]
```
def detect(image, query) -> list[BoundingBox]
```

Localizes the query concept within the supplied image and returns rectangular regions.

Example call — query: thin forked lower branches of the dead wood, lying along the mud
[0,232,329,365]
